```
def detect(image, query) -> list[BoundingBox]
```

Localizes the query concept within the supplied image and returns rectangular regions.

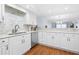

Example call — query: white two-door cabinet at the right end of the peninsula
[60,33,79,52]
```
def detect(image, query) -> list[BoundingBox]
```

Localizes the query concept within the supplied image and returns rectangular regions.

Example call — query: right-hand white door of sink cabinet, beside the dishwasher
[21,34,31,54]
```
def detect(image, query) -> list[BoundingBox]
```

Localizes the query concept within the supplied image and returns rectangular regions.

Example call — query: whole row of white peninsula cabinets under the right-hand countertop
[38,32,79,53]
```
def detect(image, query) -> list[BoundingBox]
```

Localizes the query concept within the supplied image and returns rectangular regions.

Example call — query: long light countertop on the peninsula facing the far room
[38,29,79,34]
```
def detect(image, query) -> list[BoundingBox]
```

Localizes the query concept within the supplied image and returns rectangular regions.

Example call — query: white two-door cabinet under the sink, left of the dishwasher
[9,35,31,55]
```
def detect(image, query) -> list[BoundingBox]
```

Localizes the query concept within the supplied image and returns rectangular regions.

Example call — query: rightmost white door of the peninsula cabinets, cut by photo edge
[68,34,79,52]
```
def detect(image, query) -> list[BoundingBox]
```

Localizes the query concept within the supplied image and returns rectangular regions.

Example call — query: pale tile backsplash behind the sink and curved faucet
[0,12,25,34]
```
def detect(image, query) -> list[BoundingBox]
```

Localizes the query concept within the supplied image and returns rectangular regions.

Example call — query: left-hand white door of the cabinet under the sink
[9,36,22,55]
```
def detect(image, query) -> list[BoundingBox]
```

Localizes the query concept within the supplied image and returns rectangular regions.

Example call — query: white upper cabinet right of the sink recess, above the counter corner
[16,4,37,25]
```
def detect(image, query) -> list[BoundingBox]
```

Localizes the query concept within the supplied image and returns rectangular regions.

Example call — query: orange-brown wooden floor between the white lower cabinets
[25,45,74,55]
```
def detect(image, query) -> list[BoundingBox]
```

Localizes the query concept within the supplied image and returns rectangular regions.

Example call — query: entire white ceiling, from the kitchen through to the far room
[17,4,79,20]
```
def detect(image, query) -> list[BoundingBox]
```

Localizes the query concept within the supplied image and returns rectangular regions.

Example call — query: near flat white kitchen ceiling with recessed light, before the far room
[19,4,79,16]
